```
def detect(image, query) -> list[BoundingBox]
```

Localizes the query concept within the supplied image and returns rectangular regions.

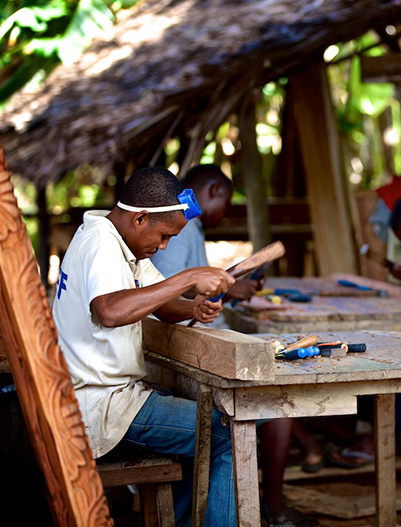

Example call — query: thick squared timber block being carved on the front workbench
[142,318,275,381]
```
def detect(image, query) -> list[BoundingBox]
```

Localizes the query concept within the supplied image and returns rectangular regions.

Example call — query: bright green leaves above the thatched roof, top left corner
[0,0,136,105]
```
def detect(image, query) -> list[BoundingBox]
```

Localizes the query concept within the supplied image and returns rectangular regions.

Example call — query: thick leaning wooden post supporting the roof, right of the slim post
[290,57,358,276]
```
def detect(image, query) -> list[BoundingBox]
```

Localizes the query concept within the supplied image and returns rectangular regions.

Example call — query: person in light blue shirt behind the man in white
[152,164,264,314]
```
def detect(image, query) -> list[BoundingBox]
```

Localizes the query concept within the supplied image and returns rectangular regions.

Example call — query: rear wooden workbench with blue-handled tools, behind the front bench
[224,275,401,334]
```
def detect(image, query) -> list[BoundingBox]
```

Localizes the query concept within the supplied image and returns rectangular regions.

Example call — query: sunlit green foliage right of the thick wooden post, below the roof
[328,32,401,189]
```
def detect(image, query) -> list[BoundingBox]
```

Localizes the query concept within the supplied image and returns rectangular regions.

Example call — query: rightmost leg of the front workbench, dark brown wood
[375,393,397,527]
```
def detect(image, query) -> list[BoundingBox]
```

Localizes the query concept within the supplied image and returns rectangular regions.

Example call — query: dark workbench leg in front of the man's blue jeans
[192,384,213,527]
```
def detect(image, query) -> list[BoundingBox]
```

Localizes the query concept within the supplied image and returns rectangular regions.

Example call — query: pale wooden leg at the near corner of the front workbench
[230,419,261,527]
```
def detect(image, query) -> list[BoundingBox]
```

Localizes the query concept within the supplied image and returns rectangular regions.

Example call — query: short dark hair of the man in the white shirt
[119,167,184,221]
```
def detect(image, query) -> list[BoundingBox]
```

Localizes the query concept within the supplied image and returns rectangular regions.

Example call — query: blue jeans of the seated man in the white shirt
[124,391,236,527]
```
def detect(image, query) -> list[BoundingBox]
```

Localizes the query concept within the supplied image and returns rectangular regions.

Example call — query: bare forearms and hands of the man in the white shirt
[91,267,234,327]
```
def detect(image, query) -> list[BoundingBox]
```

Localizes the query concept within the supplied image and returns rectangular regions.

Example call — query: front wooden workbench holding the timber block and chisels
[147,331,401,527]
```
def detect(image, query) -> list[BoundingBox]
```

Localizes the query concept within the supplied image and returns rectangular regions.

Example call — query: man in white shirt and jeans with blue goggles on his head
[53,167,235,527]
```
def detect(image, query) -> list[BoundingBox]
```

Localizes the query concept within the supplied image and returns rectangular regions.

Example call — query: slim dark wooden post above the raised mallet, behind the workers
[240,92,271,251]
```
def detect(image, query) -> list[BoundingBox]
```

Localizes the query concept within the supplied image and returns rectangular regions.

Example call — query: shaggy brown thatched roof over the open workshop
[0,0,401,186]
